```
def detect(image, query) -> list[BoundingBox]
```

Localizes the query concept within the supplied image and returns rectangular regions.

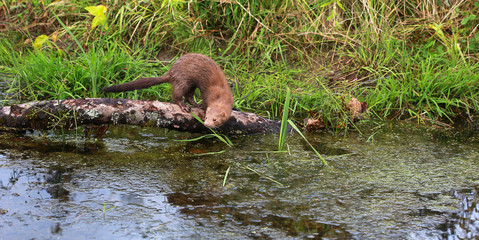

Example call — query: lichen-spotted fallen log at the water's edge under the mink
[0,98,281,135]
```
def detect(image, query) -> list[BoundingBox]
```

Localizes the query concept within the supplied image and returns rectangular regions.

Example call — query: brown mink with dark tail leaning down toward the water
[102,53,233,128]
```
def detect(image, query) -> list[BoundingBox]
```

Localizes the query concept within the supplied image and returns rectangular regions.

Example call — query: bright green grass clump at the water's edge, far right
[367,41,479,121]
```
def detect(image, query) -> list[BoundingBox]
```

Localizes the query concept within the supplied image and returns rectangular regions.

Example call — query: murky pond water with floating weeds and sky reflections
[0,123,479,239]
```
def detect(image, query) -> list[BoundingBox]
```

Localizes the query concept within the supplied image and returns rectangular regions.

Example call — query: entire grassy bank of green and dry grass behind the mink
[0,0,479,131]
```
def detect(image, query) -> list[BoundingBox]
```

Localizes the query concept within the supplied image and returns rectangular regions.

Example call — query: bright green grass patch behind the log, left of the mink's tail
[9,43,147,101]
